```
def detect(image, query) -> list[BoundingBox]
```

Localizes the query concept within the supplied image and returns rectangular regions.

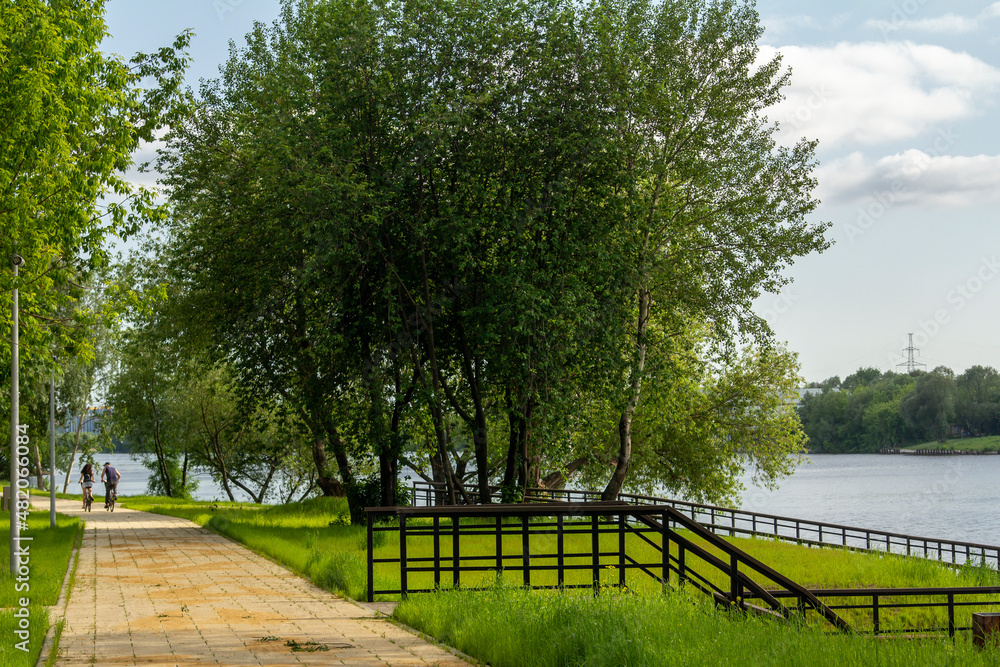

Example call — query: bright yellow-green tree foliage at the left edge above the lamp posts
[0,0,188,386]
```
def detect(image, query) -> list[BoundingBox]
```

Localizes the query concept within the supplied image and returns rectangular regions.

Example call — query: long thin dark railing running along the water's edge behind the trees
[411,482,1000,571]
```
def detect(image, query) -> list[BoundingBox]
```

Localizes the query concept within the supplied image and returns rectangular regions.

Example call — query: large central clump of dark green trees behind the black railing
[157,0,828,515]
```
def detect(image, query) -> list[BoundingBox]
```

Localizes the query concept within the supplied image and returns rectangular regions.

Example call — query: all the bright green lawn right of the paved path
[125,498,1000,665]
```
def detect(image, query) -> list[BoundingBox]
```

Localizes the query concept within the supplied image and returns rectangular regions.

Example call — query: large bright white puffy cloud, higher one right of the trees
[760,42,1000,148]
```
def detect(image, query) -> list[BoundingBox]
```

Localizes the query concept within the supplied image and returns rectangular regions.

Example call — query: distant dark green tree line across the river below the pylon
[799,366,1000,453]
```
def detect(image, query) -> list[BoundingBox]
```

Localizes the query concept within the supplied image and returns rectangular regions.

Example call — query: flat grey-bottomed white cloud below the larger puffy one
[816,150,1000,208]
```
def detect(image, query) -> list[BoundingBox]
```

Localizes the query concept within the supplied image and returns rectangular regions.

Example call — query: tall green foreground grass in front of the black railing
[394,588,1000,667]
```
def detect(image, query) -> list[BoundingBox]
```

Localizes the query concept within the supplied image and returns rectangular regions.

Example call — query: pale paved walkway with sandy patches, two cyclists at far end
[38,499,469,667]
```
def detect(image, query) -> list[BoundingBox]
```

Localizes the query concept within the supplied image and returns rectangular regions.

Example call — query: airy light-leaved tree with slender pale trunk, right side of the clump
[586,1,829,500]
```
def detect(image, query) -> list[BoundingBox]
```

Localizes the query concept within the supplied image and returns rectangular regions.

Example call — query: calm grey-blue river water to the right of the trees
[742,454,1000,545]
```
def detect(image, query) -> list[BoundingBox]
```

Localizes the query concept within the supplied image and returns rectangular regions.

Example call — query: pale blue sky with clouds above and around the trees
[103,0,1000,381]
